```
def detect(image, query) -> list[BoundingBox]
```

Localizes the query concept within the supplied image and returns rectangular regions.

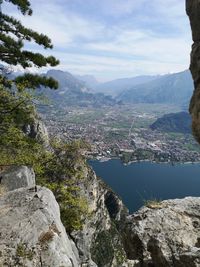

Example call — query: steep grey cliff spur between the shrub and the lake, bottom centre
[72,167,128,267]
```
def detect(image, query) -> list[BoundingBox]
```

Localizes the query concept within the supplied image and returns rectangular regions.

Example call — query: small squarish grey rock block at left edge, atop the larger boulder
[1,166,35,191]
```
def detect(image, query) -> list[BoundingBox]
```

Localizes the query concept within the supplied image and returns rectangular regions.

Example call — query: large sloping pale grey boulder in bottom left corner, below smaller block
[0,187,80,267]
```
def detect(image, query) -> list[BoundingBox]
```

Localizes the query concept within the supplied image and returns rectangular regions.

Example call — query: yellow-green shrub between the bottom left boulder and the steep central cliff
[38,142,88,232]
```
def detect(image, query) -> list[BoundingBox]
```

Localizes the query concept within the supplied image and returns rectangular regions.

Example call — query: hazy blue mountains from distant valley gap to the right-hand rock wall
[75,70,193,108]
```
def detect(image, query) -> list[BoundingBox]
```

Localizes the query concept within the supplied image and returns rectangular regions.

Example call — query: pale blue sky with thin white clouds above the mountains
[2,0,192,81]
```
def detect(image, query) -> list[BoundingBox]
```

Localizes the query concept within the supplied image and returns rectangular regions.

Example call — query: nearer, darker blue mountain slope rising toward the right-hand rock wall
[117,70,193,105]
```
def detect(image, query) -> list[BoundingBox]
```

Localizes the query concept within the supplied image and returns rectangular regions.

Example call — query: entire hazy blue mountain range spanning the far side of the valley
[10,69,193,110]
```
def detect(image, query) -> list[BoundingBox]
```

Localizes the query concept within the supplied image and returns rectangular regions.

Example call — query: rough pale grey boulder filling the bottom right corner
[124,197,200,267]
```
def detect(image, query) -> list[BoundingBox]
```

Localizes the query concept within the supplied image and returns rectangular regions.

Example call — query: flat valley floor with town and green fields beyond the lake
[39,104,200,163]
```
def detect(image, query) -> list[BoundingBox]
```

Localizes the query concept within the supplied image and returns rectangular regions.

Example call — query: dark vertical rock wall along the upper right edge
[186,0,200,143]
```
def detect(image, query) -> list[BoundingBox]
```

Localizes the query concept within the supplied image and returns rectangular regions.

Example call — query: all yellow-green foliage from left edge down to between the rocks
[0,84,87,232]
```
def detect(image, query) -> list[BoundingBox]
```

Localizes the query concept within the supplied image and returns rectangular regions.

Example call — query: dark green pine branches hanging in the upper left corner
[0,0,59,89]
